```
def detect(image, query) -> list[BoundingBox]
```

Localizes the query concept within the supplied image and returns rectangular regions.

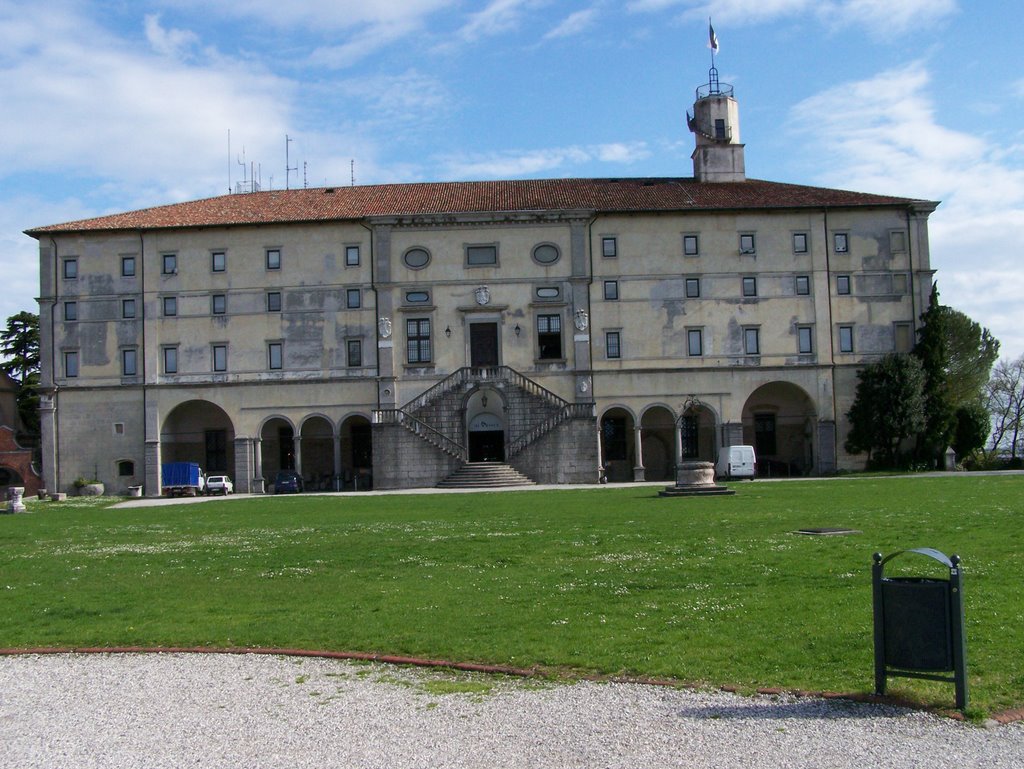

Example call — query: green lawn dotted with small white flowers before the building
[0,475,1024,711]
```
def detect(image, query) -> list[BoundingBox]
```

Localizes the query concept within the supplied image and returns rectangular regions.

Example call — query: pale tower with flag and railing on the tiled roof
[686,58,746,181]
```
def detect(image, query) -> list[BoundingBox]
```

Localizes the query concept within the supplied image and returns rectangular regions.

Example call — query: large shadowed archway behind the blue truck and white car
[160,399,234,474]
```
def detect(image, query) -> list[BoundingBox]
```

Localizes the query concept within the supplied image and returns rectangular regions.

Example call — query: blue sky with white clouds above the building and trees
[0,0,1024,357]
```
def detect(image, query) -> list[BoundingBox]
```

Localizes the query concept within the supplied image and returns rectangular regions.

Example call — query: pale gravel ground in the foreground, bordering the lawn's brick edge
[0,654,1024,769]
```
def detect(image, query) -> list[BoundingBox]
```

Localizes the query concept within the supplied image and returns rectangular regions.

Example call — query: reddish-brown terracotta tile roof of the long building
[26,177,937,237]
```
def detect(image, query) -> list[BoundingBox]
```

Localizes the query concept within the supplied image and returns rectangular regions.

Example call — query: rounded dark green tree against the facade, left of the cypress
[846,353,925,467]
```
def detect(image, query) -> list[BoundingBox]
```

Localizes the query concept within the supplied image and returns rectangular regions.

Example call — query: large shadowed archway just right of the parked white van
[742,381,817,477]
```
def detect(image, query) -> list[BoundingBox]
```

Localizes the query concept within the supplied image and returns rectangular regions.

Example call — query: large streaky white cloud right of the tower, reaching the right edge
[788,62,1024,356]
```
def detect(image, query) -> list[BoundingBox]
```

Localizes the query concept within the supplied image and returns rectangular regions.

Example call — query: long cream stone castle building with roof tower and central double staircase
[29,69,937,495]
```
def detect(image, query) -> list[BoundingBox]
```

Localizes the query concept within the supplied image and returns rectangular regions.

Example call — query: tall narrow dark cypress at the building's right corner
[913,284,956,465]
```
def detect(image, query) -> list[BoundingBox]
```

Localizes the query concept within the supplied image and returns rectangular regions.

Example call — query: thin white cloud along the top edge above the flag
[627,0,956,38]
